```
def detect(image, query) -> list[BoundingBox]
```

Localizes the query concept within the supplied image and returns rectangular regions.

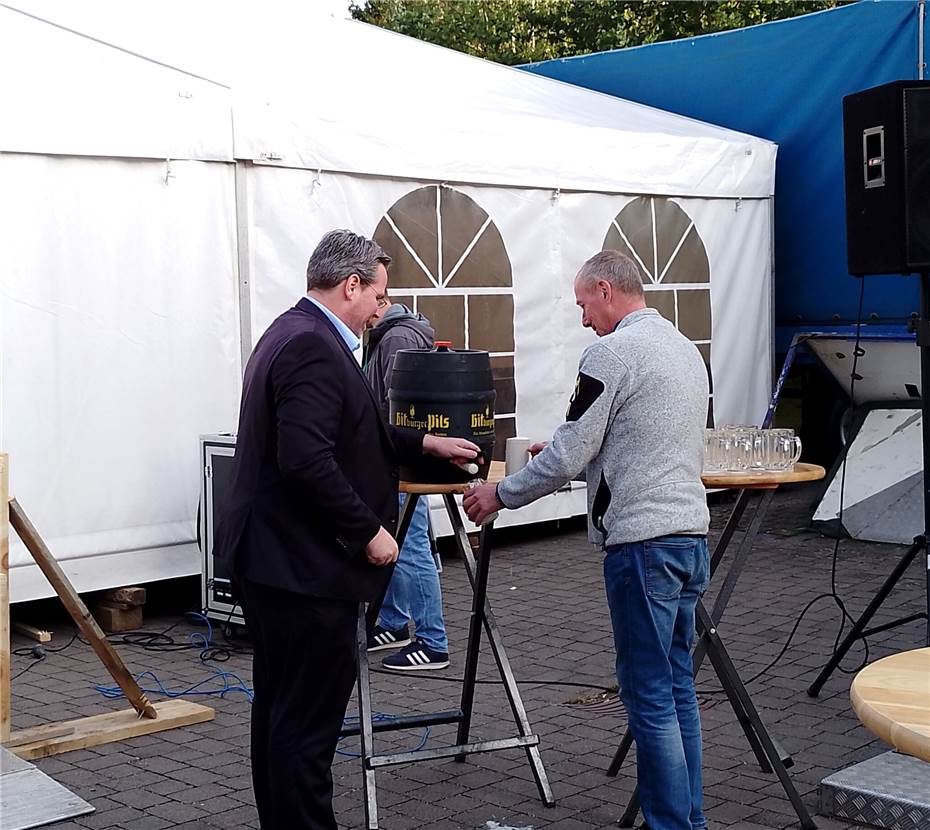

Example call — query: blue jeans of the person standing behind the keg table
[379,496,449,652]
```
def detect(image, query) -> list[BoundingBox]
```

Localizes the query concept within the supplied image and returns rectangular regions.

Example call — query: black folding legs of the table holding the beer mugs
[607,488,823,830]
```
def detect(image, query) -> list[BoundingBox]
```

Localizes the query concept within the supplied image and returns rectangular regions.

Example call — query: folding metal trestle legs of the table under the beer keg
[342,484,555,830]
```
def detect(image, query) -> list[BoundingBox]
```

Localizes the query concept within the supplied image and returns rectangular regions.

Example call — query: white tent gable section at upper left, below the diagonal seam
[0,8,232,160]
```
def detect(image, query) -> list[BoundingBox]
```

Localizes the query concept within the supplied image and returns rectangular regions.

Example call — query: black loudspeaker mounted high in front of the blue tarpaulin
[843,81,930,276]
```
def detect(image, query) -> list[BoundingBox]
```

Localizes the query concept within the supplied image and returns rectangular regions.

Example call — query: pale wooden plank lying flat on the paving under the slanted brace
[9,699,214,761]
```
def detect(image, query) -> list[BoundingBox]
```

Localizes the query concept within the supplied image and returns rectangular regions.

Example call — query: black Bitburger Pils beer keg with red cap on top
[388,341,496,483]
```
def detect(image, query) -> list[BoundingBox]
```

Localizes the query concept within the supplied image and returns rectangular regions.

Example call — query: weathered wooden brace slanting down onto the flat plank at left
[10,499,158,718]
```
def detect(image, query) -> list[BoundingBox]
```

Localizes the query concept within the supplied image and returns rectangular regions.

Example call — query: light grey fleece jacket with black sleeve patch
[498,308,709,546]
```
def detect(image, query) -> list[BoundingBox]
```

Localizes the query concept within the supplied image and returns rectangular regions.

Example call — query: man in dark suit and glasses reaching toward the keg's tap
[214,231,478,830]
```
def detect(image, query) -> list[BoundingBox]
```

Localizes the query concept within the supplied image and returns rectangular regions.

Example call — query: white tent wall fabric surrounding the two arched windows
[249,172,772,520]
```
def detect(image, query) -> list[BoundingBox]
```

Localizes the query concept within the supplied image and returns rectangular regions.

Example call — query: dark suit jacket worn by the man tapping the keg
[213,298,423,600]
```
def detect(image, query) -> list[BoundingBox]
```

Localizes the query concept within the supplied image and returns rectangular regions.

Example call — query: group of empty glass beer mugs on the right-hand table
[704,424,801,473]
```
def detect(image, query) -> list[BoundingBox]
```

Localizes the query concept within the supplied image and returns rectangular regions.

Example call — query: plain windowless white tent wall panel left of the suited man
[0,155,239,576]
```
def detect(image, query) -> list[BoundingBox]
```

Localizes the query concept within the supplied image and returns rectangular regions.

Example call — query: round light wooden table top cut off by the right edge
[849,648,930,761]
